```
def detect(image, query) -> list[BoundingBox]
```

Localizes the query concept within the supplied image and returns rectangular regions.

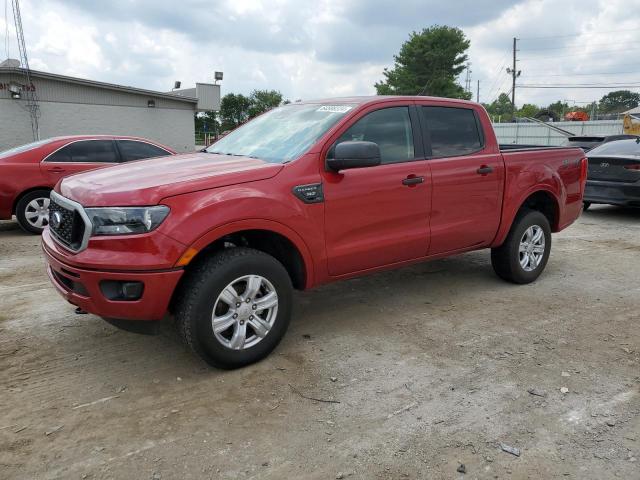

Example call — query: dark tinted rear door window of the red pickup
[422,107,483,158]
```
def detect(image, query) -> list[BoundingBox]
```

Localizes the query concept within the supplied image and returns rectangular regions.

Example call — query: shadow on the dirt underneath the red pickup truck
[64,251,504,376]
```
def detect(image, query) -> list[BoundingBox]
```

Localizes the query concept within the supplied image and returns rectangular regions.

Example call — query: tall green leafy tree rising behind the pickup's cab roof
[375,25,471,99]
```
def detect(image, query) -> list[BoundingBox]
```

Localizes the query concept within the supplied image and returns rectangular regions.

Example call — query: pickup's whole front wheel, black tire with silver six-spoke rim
[175,247,293,368]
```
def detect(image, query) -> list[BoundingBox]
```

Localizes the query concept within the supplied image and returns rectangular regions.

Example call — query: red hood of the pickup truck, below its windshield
[56,152,283,207]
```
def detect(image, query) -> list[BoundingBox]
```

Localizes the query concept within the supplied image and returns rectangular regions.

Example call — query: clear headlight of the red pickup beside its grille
[85,205,169,235]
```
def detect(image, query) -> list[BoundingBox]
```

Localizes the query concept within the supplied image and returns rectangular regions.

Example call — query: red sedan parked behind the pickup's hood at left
[0,135,176,234]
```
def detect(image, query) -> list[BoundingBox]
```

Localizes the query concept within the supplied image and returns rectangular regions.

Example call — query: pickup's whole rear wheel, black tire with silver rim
[491,210,551,284]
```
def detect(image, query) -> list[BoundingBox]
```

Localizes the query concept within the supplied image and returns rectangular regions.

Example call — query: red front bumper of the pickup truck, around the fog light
[42,238,184,320]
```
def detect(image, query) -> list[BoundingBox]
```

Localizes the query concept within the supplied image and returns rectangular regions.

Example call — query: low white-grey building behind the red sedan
[0,62,220,152]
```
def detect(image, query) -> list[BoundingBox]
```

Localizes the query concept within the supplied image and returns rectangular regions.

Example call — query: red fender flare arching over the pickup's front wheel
[176,218,315,289]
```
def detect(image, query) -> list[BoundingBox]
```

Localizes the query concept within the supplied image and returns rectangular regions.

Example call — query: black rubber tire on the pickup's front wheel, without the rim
[174,247,293,369]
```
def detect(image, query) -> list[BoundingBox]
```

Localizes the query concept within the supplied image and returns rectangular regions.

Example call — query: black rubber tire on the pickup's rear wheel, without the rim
[491,210,551,284]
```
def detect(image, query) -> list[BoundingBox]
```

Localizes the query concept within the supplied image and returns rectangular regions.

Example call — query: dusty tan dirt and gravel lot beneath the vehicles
[0,207,640,479]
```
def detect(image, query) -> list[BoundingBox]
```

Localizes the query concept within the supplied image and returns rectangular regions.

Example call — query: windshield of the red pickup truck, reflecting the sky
[205,104,354,163]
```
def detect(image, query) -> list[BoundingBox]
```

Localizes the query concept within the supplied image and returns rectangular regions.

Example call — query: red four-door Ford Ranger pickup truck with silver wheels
[43,97,587,368]
